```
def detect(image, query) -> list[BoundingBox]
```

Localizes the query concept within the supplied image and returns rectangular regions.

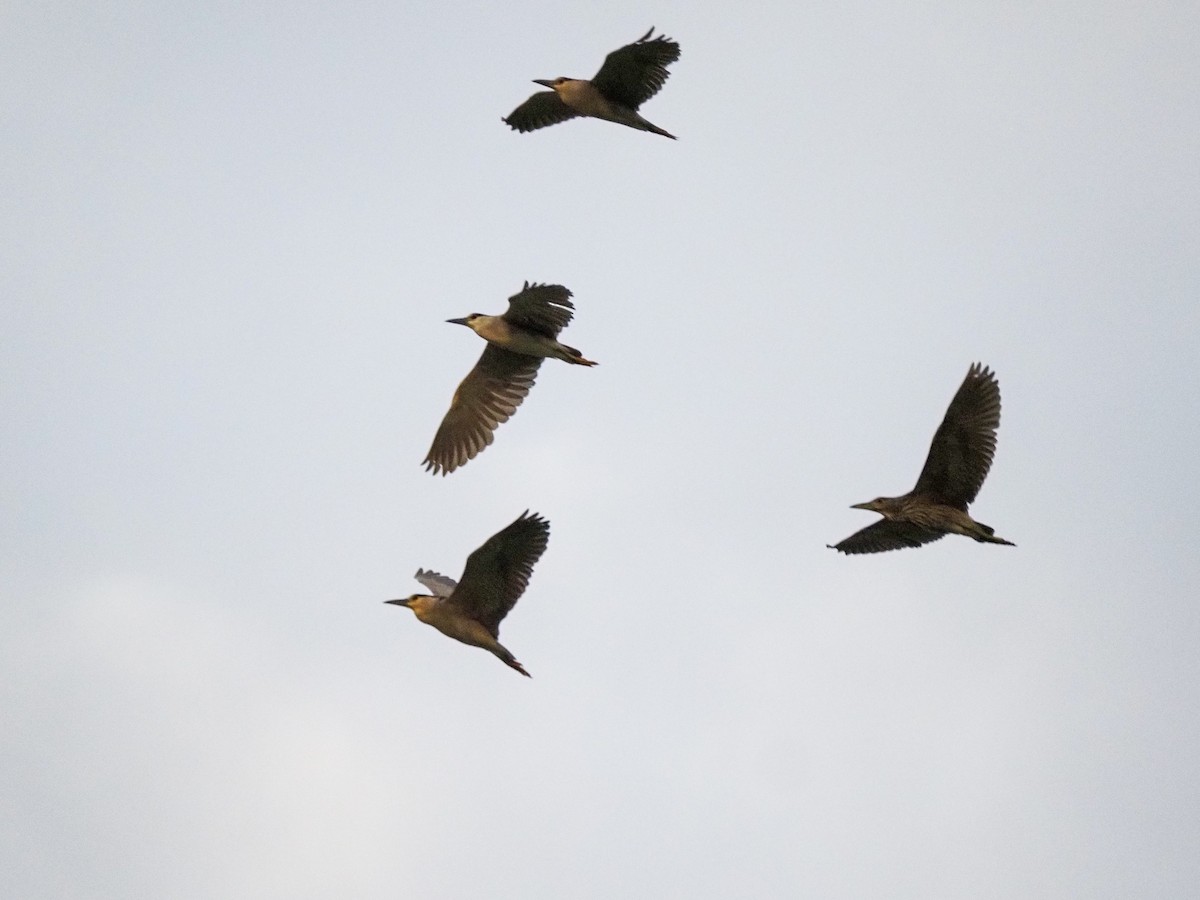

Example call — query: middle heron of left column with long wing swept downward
[425,281,596,475]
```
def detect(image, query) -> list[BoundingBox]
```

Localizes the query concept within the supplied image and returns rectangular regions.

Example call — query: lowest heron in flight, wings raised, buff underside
[384,510,550,678]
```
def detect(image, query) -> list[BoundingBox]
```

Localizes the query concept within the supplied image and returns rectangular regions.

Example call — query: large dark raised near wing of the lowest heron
[450,510,550,637]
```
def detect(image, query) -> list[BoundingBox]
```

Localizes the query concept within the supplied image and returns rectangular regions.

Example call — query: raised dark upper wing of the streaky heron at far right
[912,362,1000,511]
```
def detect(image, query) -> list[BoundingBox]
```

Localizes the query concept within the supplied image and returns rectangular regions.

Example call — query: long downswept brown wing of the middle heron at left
[425,343,541,475]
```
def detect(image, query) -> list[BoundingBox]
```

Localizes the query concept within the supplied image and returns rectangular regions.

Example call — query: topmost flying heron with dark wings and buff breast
[503,28,679,140]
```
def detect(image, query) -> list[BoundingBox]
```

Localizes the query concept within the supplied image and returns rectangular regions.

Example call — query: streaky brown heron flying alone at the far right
[829,362,1015,553]
